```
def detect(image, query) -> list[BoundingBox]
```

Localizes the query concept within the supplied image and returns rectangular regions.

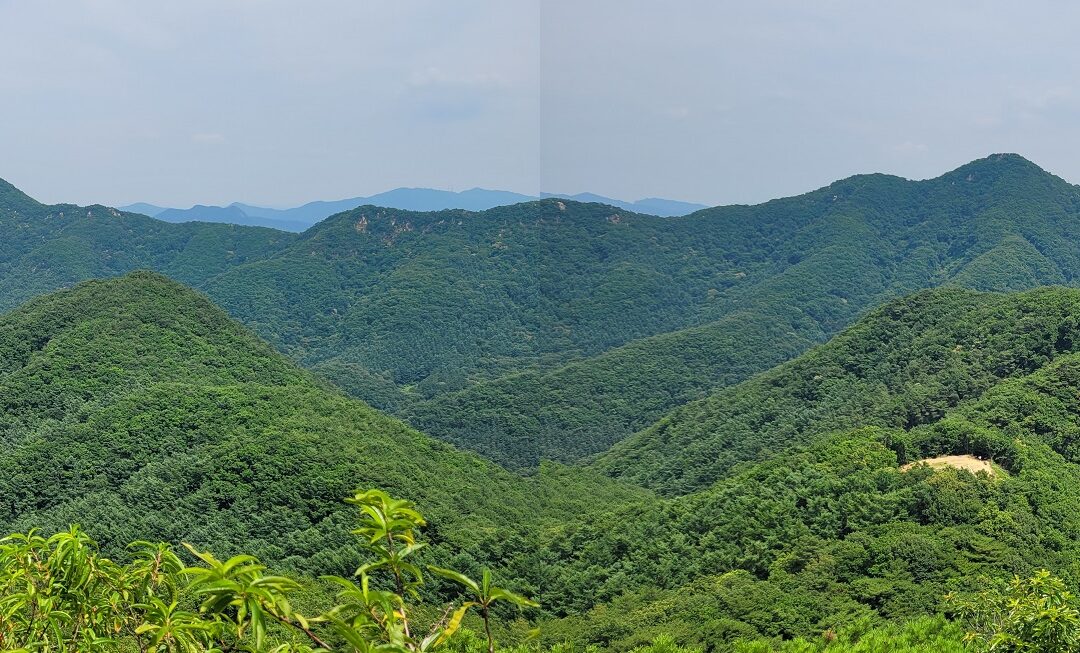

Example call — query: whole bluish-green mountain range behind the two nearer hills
[10,154,1080,467]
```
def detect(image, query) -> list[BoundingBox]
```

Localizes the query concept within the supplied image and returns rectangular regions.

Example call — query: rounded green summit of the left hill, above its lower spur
[0,270,302,384]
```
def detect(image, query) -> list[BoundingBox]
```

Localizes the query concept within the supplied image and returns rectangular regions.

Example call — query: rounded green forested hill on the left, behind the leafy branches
[0,272,647,583]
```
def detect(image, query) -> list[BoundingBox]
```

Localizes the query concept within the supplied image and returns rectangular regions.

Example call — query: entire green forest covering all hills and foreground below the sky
[8,155,1080,653]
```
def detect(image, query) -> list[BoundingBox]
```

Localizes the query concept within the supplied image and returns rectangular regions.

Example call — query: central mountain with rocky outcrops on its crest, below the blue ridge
[205,200,760,397]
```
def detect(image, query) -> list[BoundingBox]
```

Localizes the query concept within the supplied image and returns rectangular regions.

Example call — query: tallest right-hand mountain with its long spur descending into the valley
[402,155,1080,466]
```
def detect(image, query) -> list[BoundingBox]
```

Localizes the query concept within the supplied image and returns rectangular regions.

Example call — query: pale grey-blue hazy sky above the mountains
[0,0,1080,206]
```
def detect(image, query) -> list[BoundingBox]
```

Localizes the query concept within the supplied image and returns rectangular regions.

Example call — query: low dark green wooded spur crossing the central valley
[408,312,813,467]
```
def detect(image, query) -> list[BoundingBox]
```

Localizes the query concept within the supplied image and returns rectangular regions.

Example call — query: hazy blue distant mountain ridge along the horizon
[119,188,707,232]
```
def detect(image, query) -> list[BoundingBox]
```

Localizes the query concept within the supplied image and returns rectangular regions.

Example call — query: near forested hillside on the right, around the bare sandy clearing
[533,288,1080,651]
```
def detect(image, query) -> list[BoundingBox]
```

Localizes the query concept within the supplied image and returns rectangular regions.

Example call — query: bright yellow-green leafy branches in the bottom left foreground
[0,490,537,653]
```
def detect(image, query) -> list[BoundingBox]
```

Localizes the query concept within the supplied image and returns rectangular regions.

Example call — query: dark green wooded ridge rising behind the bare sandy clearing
[596,289,1080,494]
